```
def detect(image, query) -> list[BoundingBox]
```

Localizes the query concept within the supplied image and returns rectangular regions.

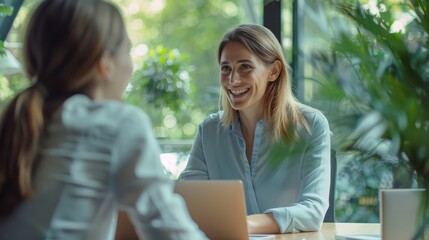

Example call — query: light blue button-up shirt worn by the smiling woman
[180,105,330,233]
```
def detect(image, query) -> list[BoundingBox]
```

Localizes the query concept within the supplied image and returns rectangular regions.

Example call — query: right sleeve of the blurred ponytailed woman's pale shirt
[112,109,206,239]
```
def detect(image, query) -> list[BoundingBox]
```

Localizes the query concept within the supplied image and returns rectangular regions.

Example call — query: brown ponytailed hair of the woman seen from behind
[0,0,126,215]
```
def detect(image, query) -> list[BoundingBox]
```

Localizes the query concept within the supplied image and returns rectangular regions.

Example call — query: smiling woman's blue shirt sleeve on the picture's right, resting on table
[265,112,331,233]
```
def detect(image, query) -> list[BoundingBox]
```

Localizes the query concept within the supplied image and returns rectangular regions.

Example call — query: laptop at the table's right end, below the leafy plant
[335,188,425,240]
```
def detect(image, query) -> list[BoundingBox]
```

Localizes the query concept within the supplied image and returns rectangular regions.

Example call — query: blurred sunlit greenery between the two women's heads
[115,0,251,139]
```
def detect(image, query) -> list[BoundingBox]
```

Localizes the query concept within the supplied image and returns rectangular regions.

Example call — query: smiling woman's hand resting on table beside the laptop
[247,213,280,234]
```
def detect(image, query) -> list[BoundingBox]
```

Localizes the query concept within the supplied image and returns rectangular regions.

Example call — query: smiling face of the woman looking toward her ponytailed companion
[220,42,275,115]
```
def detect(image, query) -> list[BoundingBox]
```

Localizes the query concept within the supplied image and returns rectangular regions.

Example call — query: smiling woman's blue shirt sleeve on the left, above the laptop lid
[179,123,209,180]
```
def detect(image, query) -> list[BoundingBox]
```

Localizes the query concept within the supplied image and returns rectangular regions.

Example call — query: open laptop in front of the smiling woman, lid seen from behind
[175,180,275,240]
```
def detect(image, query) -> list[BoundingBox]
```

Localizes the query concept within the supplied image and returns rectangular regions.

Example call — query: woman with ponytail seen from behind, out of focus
[0,0,206,240]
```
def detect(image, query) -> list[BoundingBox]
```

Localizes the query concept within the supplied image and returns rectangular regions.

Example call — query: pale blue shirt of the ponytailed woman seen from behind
[0,95,206,240]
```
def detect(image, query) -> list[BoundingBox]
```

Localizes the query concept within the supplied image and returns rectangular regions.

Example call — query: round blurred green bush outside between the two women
[126,46,192,112]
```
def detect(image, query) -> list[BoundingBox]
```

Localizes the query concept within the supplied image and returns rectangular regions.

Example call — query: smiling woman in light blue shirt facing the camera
[179,24,331,233]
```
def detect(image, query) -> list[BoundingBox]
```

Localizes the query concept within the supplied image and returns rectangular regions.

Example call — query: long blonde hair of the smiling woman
[218,24,309,142]
